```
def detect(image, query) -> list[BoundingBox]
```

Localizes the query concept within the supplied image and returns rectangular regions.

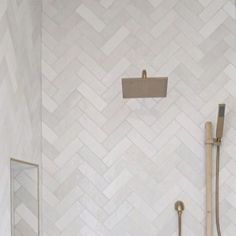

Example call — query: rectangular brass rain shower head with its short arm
[122,70,168,98]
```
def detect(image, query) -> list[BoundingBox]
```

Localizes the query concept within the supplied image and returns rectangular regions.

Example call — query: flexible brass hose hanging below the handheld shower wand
[215,145,221,236]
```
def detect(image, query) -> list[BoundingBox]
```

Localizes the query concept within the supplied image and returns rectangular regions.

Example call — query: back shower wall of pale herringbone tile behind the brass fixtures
[42,0,236,236]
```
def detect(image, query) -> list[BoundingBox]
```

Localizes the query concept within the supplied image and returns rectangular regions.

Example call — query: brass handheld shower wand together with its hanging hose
[214,104,225,236]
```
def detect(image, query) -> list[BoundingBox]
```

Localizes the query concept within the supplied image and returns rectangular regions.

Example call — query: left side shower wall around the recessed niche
[0,0,42,236]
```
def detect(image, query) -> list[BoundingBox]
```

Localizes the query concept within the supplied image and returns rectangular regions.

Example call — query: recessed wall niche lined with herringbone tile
[11,163,39,236]
